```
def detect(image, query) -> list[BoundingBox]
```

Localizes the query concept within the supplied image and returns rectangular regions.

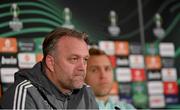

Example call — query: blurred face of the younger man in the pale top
[86,55,113,97]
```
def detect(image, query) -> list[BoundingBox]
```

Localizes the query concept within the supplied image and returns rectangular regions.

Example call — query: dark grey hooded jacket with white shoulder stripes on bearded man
[0,62,98,109]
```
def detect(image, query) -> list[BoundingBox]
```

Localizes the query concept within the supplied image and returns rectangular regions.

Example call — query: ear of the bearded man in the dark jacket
[45,55,54,72]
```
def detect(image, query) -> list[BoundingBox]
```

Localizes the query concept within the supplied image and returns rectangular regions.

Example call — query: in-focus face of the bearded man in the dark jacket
[53,37,89,90]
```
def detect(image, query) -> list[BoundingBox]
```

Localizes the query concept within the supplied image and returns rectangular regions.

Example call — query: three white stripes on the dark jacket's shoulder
[13,80,32,109]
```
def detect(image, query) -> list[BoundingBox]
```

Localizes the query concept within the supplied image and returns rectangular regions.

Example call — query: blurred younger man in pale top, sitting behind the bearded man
[85,48,135,110]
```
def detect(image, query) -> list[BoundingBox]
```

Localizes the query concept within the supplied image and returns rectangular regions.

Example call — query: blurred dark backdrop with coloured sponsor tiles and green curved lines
[0,0,180,108]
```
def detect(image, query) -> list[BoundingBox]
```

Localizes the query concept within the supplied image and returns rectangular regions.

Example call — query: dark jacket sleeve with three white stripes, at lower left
[0,80,36,109]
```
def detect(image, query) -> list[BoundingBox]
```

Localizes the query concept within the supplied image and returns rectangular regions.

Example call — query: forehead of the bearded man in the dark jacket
[57,36,89,55]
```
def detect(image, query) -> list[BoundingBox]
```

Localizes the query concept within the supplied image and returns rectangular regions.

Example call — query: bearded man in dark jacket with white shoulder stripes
[1,28,98,109]
